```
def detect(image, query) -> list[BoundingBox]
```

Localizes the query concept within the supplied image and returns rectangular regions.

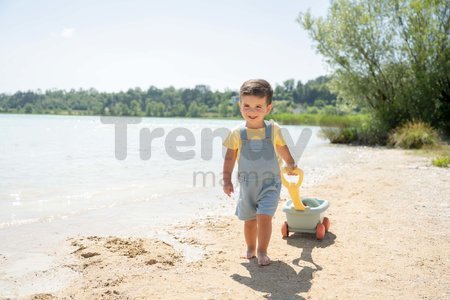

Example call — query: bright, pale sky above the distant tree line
[0,0,329,93]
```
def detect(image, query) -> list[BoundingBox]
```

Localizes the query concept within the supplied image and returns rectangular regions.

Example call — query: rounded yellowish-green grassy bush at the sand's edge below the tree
[389,121,439,149]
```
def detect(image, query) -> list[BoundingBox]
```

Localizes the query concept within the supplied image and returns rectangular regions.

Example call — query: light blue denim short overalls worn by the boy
[236,121,281,220]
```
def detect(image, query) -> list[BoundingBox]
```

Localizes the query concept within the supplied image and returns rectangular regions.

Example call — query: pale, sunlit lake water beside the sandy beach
[0,115,348,297]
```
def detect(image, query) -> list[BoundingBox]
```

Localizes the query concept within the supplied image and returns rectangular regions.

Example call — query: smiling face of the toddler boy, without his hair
[240,95,272,128]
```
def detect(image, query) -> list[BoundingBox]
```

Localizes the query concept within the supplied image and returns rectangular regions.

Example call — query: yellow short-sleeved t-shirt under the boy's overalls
[223,122,286,166]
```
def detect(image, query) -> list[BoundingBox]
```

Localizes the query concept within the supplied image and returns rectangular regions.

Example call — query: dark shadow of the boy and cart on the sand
[231,232,336,299]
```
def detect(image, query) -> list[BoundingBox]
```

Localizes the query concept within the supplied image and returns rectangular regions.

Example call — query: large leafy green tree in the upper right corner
[298,0,450,133]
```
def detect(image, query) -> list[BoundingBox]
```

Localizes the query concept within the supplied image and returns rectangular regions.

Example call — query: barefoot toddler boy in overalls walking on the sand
[223,79,296,266]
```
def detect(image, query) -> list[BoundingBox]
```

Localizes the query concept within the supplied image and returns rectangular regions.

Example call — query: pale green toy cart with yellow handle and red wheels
[281,168,330,240]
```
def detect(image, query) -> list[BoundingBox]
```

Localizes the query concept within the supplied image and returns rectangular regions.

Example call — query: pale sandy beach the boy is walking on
[28,147,450,299]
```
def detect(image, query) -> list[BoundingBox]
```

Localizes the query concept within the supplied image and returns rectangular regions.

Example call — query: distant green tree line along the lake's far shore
[0,76,336,117]
